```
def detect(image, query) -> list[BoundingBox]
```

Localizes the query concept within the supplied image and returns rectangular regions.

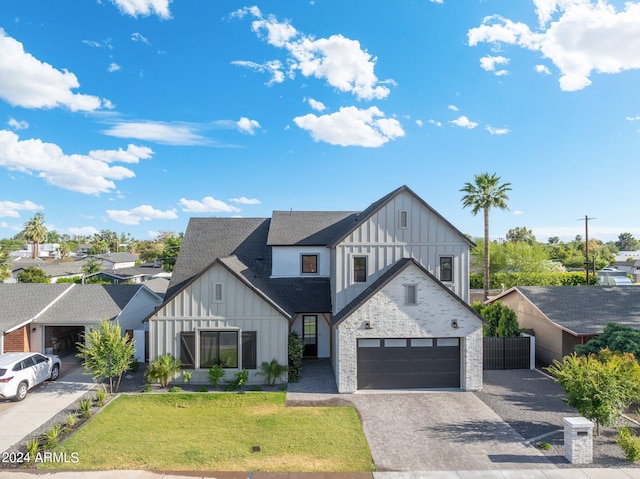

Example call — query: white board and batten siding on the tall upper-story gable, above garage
[332,192,469,314]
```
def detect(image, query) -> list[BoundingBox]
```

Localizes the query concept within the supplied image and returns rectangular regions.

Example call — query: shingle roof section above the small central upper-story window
[267,211,358,246]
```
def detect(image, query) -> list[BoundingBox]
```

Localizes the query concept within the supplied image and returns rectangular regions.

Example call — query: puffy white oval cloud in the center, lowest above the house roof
[293,106,404,148]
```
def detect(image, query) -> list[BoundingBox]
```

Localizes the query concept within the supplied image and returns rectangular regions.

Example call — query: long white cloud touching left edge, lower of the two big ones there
[0,130,153,195]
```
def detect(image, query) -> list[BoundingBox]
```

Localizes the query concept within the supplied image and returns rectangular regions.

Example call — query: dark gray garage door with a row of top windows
[358,338,460,389]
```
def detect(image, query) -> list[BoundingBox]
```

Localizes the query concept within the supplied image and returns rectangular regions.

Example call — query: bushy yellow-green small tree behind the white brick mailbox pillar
[547,349,640,434]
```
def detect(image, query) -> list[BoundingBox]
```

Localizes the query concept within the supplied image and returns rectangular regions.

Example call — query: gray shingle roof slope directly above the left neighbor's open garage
[36,284,142,324]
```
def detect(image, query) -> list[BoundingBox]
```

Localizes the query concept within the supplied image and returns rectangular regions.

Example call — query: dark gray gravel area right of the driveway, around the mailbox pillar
[476,369,640,468]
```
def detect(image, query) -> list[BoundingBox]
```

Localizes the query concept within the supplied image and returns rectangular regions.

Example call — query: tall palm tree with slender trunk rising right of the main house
[460,173,511,300]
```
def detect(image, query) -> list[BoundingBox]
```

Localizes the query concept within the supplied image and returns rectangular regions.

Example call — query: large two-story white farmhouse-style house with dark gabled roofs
[148,186,482,393]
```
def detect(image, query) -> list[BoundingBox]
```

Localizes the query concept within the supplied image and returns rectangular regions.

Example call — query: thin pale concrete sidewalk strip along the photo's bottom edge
[0,468,640,479]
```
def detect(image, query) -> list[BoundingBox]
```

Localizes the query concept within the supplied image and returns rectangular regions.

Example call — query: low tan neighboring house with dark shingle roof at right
[489,286,640,364]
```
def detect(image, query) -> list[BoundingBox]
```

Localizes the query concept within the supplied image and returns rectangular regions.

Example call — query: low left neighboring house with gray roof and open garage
[0,283,162,355]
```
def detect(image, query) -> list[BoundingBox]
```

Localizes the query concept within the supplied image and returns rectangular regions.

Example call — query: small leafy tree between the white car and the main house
[77,321,134,394]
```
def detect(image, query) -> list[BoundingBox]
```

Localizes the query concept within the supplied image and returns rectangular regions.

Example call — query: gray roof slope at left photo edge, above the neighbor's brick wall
[0,283,72,331]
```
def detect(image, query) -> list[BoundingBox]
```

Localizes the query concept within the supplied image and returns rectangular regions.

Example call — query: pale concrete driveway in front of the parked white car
[0,365,96,456]
